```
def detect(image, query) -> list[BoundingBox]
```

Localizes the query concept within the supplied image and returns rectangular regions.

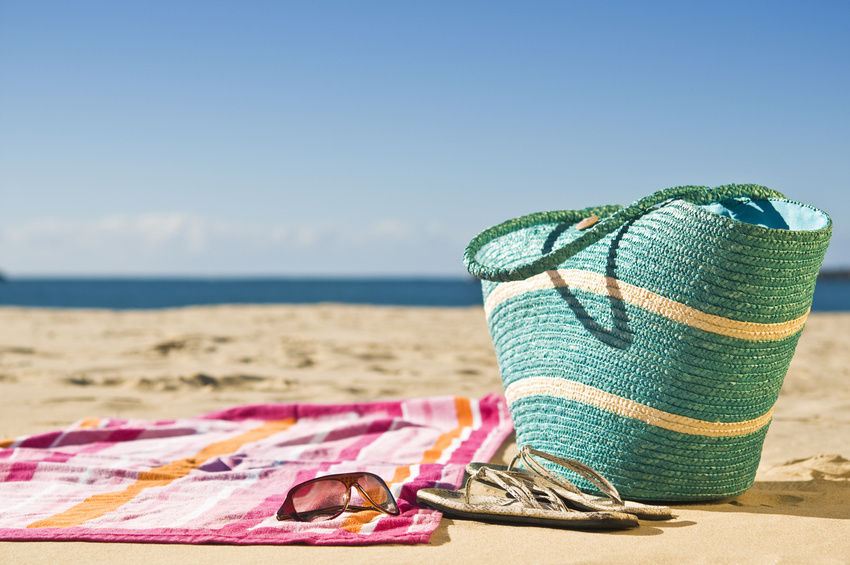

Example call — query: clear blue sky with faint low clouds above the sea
[0,0,850,275]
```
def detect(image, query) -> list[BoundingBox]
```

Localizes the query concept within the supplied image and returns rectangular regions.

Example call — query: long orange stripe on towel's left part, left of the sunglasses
[27,418,295,528]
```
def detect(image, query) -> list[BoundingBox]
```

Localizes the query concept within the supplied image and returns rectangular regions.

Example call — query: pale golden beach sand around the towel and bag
[0,305,850,564]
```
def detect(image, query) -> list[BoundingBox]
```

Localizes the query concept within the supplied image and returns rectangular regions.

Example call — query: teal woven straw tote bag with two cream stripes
[464,185,832,501]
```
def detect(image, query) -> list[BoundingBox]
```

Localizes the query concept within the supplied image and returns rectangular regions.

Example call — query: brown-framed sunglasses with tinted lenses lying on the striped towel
[276,472,399,522]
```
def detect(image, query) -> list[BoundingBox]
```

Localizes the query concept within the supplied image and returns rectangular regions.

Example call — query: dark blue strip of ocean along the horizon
[0,278,850,312]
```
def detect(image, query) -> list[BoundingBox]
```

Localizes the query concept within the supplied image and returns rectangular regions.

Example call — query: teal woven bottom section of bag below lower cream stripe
[511,398,767,502]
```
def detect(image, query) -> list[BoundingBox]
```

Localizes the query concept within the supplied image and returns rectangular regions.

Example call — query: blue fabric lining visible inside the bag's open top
[702,200,829,231]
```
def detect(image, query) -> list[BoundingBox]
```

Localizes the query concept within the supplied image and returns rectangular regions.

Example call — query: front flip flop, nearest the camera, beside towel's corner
[416,467,638,530]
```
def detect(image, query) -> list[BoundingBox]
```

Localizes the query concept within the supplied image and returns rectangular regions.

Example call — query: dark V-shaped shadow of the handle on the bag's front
[541,220,634,349]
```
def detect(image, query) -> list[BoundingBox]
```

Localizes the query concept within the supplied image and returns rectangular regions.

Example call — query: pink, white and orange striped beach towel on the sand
[0,395,512,545]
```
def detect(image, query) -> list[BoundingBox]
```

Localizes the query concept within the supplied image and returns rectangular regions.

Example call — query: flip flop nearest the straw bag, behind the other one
[464,445,673,520]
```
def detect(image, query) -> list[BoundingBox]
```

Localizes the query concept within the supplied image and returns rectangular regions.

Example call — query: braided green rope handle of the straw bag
[463,184,785,282]
